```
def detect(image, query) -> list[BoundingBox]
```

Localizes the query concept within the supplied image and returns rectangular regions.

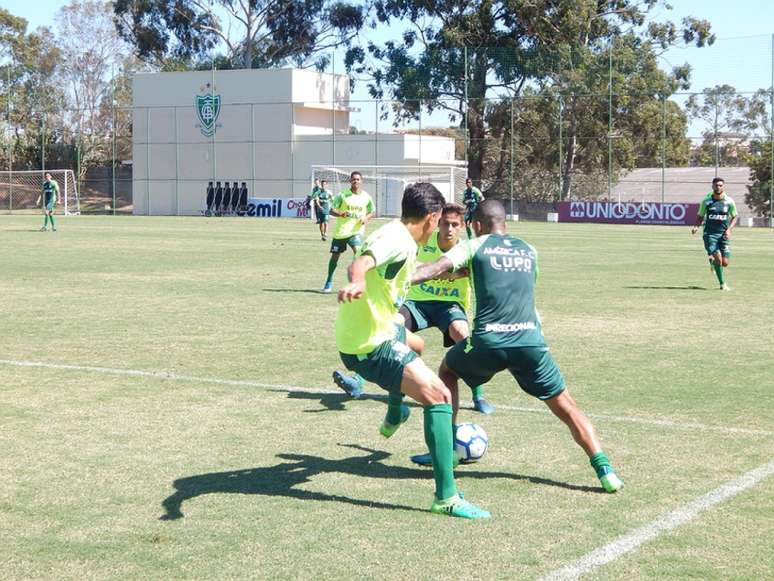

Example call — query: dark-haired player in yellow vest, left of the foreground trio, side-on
[334,180,489,518]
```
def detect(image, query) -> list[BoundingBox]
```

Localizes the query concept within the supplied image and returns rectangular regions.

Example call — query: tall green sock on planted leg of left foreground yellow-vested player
[425,403,457,500]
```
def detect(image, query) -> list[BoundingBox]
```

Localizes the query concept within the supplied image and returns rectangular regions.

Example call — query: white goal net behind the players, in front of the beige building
[312,165,467,217]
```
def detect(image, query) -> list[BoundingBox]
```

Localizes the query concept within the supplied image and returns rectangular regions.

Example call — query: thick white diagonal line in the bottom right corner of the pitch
[541,462,774,581]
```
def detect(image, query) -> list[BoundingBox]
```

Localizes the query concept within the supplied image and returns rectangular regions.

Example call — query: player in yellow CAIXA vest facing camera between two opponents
[398,204,494,414]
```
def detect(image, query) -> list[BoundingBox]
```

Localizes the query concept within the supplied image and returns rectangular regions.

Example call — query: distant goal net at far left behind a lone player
[0,169,81,215]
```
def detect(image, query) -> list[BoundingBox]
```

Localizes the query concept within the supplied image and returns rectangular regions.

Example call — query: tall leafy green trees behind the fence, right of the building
[347,0,714,195]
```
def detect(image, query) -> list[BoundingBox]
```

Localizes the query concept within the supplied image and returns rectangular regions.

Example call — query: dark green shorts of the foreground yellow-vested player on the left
[339,325,417,393]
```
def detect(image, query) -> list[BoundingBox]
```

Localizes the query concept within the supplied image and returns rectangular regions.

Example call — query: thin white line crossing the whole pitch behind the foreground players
[0,359,774,436]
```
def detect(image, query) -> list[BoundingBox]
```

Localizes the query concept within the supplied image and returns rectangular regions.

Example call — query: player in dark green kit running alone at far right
[691,178,739,290]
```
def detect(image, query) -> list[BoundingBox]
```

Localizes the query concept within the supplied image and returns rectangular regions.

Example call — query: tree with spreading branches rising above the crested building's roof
[114,0,365,69]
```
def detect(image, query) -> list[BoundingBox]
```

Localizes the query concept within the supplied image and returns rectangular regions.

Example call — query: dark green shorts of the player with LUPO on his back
[444,341,564,400]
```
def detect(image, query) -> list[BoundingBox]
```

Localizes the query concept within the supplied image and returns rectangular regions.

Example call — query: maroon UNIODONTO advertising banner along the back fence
[556,202,699,226]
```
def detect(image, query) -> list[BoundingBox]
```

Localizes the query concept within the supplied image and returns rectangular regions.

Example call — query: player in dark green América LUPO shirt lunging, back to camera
[412,200,623,492]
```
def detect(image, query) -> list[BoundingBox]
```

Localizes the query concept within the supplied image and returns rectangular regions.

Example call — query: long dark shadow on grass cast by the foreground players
[160,444,604,520]
